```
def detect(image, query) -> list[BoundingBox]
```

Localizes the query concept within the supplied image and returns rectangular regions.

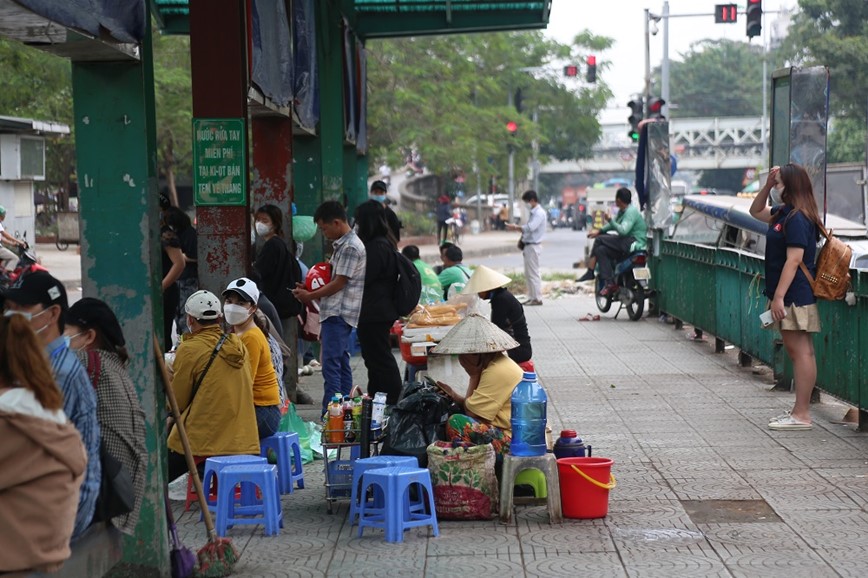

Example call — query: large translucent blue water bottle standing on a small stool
[509,371,548,456]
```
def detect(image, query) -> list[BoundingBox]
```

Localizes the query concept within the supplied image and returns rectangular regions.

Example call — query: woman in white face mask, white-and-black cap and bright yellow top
[223,277,280,439]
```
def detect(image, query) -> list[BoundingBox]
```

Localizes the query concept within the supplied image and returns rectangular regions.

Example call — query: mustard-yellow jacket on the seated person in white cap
[168,326,259,456]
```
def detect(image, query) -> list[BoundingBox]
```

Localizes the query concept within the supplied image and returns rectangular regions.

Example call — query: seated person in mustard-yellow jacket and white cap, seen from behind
[166,291,259,480]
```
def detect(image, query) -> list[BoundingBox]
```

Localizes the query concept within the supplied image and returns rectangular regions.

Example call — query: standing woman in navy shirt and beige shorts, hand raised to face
[750,163,822,430]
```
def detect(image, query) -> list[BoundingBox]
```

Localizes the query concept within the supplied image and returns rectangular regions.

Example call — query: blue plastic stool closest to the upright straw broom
[216,464,283,537]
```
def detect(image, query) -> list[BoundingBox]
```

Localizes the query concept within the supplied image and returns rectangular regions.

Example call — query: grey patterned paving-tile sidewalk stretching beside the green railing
[175,295,868,578]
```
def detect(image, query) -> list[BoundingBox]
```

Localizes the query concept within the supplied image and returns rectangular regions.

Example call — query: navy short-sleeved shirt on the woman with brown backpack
[766,205,817,307]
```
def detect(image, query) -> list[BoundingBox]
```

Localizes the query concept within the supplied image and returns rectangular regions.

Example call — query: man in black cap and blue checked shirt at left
[4,271,102,540]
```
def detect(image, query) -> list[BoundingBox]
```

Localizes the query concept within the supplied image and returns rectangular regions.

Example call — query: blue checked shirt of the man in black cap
[45,337,102,540]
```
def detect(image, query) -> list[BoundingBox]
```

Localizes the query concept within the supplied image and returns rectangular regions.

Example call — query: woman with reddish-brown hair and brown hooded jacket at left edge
[0,315,87,574]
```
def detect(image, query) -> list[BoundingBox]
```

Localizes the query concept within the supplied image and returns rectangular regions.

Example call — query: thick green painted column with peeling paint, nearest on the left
[72,19,170,576]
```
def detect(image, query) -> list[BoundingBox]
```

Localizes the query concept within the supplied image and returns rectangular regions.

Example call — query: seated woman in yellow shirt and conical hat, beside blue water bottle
[431,315,523,454]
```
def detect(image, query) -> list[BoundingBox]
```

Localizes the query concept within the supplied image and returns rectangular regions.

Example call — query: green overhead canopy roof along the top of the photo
[151,0,552,39]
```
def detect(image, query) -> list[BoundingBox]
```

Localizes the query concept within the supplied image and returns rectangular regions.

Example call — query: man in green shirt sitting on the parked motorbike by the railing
[578,187,648,297]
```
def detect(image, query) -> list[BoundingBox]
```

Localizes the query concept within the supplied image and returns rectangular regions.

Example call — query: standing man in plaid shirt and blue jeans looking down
[292,201,366,413]
